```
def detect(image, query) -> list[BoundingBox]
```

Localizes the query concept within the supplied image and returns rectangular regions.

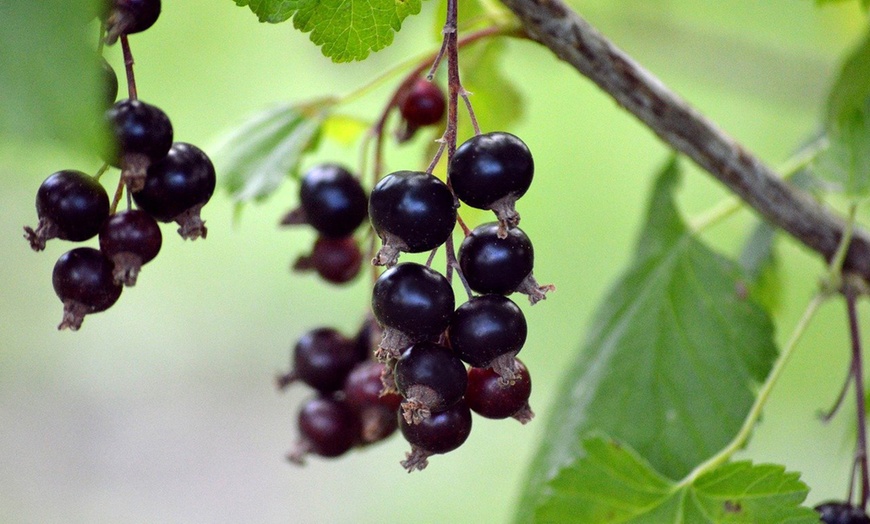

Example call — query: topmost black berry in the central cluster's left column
[369,171,456,266]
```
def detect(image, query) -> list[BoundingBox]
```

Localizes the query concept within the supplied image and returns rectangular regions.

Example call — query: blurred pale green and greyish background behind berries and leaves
[0,0,866,523]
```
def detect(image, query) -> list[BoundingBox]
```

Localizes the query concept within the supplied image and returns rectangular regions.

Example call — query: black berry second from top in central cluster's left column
[372,262,455,360]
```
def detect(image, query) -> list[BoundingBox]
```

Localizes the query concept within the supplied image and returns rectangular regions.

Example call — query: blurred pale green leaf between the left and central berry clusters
[214,99,335,204]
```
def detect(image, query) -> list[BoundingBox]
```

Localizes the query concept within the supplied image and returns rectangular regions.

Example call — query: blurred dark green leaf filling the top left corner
[0,0,105,153]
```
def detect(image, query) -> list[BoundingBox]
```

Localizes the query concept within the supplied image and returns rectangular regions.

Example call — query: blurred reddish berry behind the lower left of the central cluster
[342,360,402,444]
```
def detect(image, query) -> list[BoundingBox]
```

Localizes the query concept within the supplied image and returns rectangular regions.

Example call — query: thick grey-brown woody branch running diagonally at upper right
[502,0,870,280]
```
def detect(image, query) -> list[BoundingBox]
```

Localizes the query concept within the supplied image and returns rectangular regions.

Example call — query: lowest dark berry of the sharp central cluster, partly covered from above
[398,400,471,473]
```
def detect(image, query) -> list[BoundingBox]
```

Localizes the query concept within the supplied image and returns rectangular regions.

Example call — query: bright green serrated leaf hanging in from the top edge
[235,0,422,62]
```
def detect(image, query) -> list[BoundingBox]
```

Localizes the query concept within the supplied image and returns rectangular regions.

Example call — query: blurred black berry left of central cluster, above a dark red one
[281,164,368,238]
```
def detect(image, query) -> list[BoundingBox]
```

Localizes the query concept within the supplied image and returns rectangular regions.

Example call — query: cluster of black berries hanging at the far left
[24,0,215,330]
